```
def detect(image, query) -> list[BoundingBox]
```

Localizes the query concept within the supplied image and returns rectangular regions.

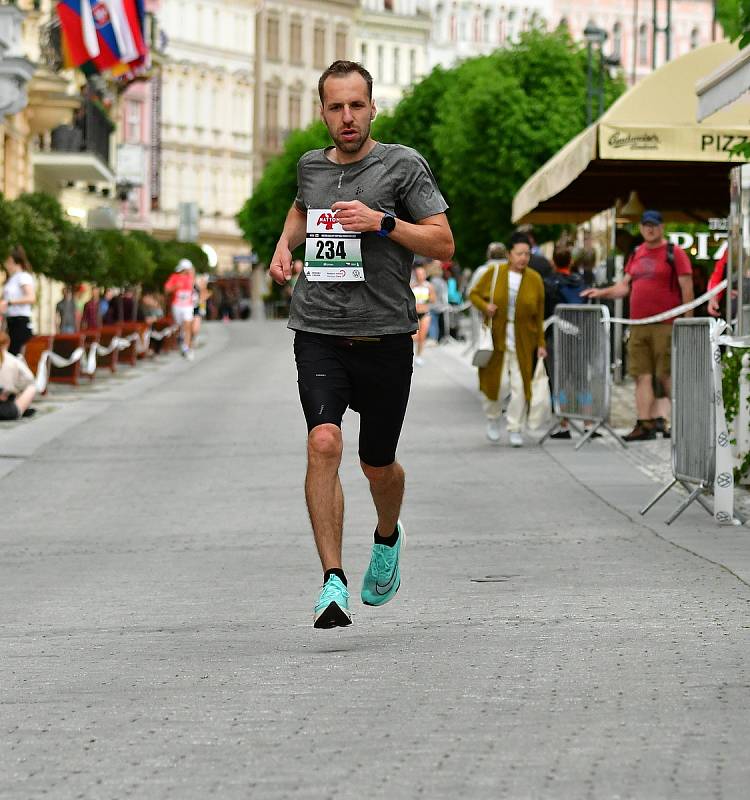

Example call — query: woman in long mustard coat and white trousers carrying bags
[469,233,547,447]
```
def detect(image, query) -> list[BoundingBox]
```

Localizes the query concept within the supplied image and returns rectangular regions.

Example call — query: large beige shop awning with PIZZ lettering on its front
[513,42,750,222]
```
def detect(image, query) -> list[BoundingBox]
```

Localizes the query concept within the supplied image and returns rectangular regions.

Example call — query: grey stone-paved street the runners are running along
[0,323,750,800]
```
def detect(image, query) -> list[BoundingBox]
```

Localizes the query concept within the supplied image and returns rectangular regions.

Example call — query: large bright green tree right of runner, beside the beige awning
[432,30,624,266]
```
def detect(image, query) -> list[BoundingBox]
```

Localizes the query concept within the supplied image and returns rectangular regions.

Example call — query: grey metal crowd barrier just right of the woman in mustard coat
[540,305,626,450]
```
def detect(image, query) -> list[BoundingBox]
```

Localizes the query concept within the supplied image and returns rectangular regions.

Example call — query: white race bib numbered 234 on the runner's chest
[305,208,365,281]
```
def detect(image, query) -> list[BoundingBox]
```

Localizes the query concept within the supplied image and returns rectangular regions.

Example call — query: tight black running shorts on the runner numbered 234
[294,331,413,467]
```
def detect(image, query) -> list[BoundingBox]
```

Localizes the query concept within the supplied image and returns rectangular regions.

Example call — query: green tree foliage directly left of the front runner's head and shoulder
[237,122,331,264]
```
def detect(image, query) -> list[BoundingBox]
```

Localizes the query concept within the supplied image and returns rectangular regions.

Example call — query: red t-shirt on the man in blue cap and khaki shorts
[625,242,693,319]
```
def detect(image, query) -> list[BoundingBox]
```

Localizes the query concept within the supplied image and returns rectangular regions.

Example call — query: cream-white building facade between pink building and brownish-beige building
[150,0,258,271]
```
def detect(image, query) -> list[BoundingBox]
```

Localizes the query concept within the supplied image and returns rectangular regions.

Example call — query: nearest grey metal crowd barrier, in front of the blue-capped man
[641,319,748,525]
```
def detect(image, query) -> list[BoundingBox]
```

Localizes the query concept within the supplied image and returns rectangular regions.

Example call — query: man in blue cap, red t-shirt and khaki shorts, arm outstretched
[581,210,693,442]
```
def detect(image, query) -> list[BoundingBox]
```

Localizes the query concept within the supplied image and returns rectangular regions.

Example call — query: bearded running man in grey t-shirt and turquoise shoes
[270,61,453,628]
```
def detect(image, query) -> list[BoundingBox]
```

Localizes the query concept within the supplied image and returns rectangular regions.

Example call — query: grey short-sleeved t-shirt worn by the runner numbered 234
[289,143,448,336]
